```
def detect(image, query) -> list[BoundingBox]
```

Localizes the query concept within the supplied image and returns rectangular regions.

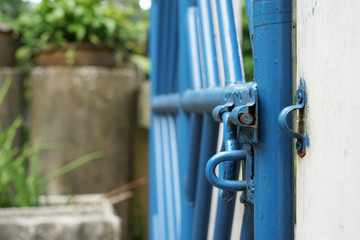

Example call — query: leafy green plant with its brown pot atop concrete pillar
[14,0,147,67]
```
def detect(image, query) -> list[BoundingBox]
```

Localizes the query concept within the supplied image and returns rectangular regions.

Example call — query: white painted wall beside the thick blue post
[296,0,360,240]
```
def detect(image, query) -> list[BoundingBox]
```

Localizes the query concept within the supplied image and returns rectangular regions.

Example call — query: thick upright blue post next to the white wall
[253,0,294,240]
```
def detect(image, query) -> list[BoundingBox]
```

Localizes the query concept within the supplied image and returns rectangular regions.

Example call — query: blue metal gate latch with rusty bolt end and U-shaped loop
[206,83,258,201]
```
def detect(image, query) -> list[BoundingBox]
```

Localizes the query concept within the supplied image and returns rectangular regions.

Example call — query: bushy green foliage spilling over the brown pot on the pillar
[13,0,148,70]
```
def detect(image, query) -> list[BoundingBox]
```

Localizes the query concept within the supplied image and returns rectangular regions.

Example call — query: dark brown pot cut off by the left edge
[0,23,18,67]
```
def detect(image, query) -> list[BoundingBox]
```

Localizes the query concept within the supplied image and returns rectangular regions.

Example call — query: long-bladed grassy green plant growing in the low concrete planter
[0,77,102,207]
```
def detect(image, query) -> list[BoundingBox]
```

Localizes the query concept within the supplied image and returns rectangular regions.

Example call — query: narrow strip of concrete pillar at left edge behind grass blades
[0,67,24,146]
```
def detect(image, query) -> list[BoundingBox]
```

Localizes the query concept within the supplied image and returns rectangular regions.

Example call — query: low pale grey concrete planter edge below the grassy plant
[0,195,120,240]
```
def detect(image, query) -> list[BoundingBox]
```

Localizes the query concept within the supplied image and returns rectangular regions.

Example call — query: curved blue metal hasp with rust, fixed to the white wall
[278,79,309,157]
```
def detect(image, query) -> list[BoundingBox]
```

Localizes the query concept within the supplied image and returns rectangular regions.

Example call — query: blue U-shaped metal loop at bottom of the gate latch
[206,150,247,191]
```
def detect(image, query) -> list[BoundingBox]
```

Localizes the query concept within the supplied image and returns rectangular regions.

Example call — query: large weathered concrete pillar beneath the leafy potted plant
[31,67,138,240]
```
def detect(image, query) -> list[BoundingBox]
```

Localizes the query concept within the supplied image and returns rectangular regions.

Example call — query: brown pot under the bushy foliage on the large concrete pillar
[35,43,116,67]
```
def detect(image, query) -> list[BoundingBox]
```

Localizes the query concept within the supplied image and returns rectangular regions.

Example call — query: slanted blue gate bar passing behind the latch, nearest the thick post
[214,0,253,240]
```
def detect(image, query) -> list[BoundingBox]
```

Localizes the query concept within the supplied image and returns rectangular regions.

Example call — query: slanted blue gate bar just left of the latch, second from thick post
[191,0,220,240]
